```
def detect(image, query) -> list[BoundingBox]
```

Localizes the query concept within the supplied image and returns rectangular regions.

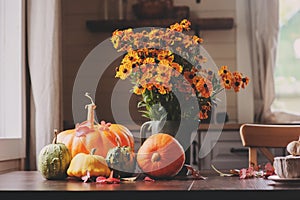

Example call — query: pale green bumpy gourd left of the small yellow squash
[38,130,72,180]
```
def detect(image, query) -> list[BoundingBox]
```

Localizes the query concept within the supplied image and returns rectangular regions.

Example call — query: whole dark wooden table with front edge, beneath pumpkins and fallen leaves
[0,171,300,199]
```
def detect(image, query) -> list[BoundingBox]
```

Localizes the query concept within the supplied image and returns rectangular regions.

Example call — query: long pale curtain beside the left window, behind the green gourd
[27,0,61,169]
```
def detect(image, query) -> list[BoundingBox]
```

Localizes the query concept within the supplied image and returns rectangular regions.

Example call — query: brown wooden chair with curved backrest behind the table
[240,124,300,167]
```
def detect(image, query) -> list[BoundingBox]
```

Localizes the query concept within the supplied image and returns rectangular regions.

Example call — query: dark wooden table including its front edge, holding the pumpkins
[0,171,300,199]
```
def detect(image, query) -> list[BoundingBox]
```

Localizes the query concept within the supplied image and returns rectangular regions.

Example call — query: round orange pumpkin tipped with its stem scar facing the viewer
[136,133,185,178]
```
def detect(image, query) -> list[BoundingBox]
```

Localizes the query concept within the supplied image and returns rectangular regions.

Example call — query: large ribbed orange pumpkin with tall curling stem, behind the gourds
[57,94,134,157]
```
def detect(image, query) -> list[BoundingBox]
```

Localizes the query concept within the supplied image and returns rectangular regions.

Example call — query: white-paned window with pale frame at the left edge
[0,0,25,161]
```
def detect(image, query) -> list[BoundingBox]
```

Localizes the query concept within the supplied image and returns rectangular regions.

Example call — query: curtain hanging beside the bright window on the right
[249,0,279,122]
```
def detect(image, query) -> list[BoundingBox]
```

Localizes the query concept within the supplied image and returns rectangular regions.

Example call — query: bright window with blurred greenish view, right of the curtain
[272,0,300,114]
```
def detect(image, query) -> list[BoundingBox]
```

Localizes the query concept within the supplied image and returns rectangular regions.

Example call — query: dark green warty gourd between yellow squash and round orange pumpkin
[105,138,136,178]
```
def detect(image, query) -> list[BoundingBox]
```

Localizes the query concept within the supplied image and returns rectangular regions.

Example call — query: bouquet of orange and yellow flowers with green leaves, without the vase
[111,19,249,121]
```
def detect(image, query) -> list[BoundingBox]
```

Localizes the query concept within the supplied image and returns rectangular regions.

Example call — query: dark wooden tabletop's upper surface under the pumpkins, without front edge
[0,171,300,191]
